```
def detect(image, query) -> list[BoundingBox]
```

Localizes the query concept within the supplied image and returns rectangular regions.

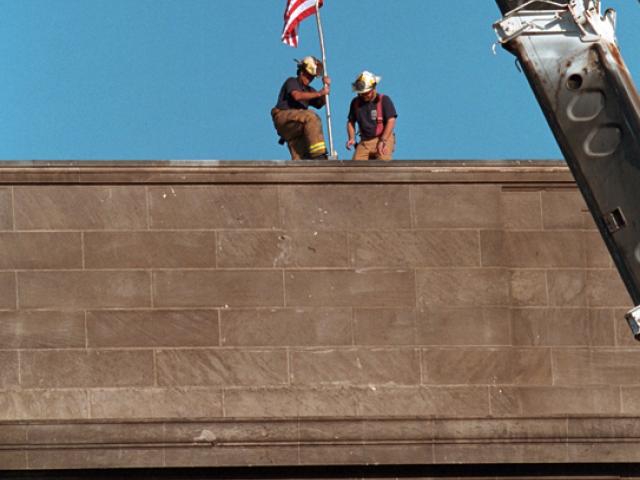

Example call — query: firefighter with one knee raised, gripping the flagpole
[271,57,331,160]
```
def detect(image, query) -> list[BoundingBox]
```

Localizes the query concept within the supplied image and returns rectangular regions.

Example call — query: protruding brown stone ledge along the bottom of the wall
[0,417,640,470]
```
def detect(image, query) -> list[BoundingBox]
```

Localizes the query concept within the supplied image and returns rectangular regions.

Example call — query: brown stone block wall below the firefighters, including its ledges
[0,162,640,470]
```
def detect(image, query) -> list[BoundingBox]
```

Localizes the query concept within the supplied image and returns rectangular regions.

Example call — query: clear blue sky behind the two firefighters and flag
[0,0,640,160]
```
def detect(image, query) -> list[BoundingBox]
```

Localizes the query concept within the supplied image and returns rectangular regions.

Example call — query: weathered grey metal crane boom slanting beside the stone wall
[494,0,640,340]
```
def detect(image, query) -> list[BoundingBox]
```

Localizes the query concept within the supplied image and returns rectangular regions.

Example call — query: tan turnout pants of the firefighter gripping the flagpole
[271,108,327,160]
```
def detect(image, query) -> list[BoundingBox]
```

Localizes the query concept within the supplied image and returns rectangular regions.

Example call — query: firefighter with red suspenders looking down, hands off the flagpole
[347,71,398,160]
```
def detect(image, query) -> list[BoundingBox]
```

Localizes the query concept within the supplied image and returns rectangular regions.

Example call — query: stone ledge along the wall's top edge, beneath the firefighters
[0,160,575,186]
